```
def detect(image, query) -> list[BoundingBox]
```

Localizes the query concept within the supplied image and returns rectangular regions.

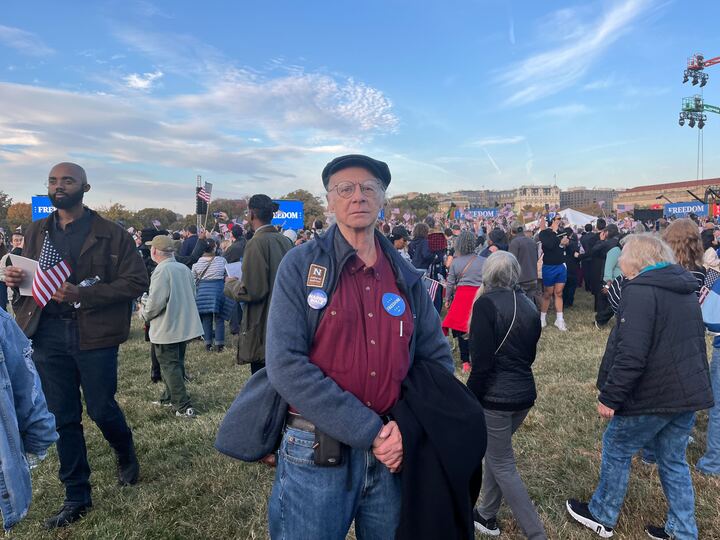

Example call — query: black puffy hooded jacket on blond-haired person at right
[598,264,713,415]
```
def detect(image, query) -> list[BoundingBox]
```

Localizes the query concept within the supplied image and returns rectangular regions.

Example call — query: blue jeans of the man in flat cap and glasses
[268,428,400,540]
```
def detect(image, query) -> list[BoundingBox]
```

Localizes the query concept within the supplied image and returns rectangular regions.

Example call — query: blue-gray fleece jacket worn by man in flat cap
[265,225,453,449]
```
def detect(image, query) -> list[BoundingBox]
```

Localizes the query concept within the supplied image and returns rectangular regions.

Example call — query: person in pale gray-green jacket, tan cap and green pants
[140,235,203,418]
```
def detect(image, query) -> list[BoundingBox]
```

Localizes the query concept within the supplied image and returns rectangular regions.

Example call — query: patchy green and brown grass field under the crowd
[12,292,720,540]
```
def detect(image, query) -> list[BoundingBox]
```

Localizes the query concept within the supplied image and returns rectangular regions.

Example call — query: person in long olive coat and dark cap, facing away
[225,194,292,373]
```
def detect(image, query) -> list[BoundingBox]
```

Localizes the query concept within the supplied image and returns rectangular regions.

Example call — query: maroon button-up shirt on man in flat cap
[310,240,413,414]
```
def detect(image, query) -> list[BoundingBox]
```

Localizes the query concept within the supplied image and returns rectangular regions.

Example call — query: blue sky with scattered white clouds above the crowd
[0,0,720,212]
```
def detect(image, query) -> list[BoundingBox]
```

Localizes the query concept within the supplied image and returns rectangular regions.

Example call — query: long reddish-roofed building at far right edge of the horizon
[613,178,720,209]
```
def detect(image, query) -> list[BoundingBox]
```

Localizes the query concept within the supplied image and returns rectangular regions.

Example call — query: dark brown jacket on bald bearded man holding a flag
[13,209,150,351]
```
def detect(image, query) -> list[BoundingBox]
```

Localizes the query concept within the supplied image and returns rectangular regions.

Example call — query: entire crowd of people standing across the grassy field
[0,155,720,539]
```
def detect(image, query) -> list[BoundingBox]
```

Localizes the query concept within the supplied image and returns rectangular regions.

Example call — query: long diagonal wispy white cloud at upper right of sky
[497,0,652,105]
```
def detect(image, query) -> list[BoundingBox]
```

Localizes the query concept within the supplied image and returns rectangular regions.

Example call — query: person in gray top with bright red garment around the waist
[442,231,486,373]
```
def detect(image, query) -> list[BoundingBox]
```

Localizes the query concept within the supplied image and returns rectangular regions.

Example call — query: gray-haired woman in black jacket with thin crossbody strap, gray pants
[467,251,547,539]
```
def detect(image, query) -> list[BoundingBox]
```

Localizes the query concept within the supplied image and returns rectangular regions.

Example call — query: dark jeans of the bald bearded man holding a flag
[33,317,133,504]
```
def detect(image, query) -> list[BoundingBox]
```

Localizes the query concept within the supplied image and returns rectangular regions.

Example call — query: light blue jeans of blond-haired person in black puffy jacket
[589,412,698,540]
